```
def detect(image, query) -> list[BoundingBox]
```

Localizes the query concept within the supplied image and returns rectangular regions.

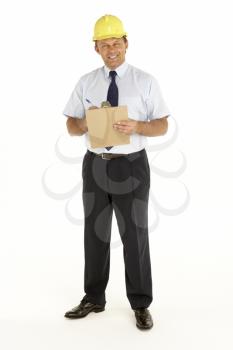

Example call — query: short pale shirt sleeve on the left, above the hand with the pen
[63,79,85,119]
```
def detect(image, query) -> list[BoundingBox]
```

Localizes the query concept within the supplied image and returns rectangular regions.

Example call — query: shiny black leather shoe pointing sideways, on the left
[64,297,105,318]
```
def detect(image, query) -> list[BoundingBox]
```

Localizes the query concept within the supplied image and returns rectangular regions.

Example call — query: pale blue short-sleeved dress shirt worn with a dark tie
[63,62,170,154]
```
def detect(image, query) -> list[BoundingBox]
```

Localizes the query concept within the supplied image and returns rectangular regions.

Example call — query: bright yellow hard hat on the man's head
[93,15,127,41]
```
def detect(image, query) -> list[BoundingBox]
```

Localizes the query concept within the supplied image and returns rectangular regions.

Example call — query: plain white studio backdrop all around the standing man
[0,0,233,350]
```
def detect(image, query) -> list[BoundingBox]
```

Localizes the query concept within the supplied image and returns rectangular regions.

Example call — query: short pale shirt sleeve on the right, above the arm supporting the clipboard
[146,77,170,120]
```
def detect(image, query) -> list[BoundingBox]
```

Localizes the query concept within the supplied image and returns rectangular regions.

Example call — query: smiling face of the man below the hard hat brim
[95,38,128,70]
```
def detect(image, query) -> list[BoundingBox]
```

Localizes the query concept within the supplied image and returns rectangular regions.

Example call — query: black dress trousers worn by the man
[82,149,153,309]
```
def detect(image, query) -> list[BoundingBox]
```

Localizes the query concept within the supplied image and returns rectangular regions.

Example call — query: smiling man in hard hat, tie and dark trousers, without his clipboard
[63,15,169,329]
